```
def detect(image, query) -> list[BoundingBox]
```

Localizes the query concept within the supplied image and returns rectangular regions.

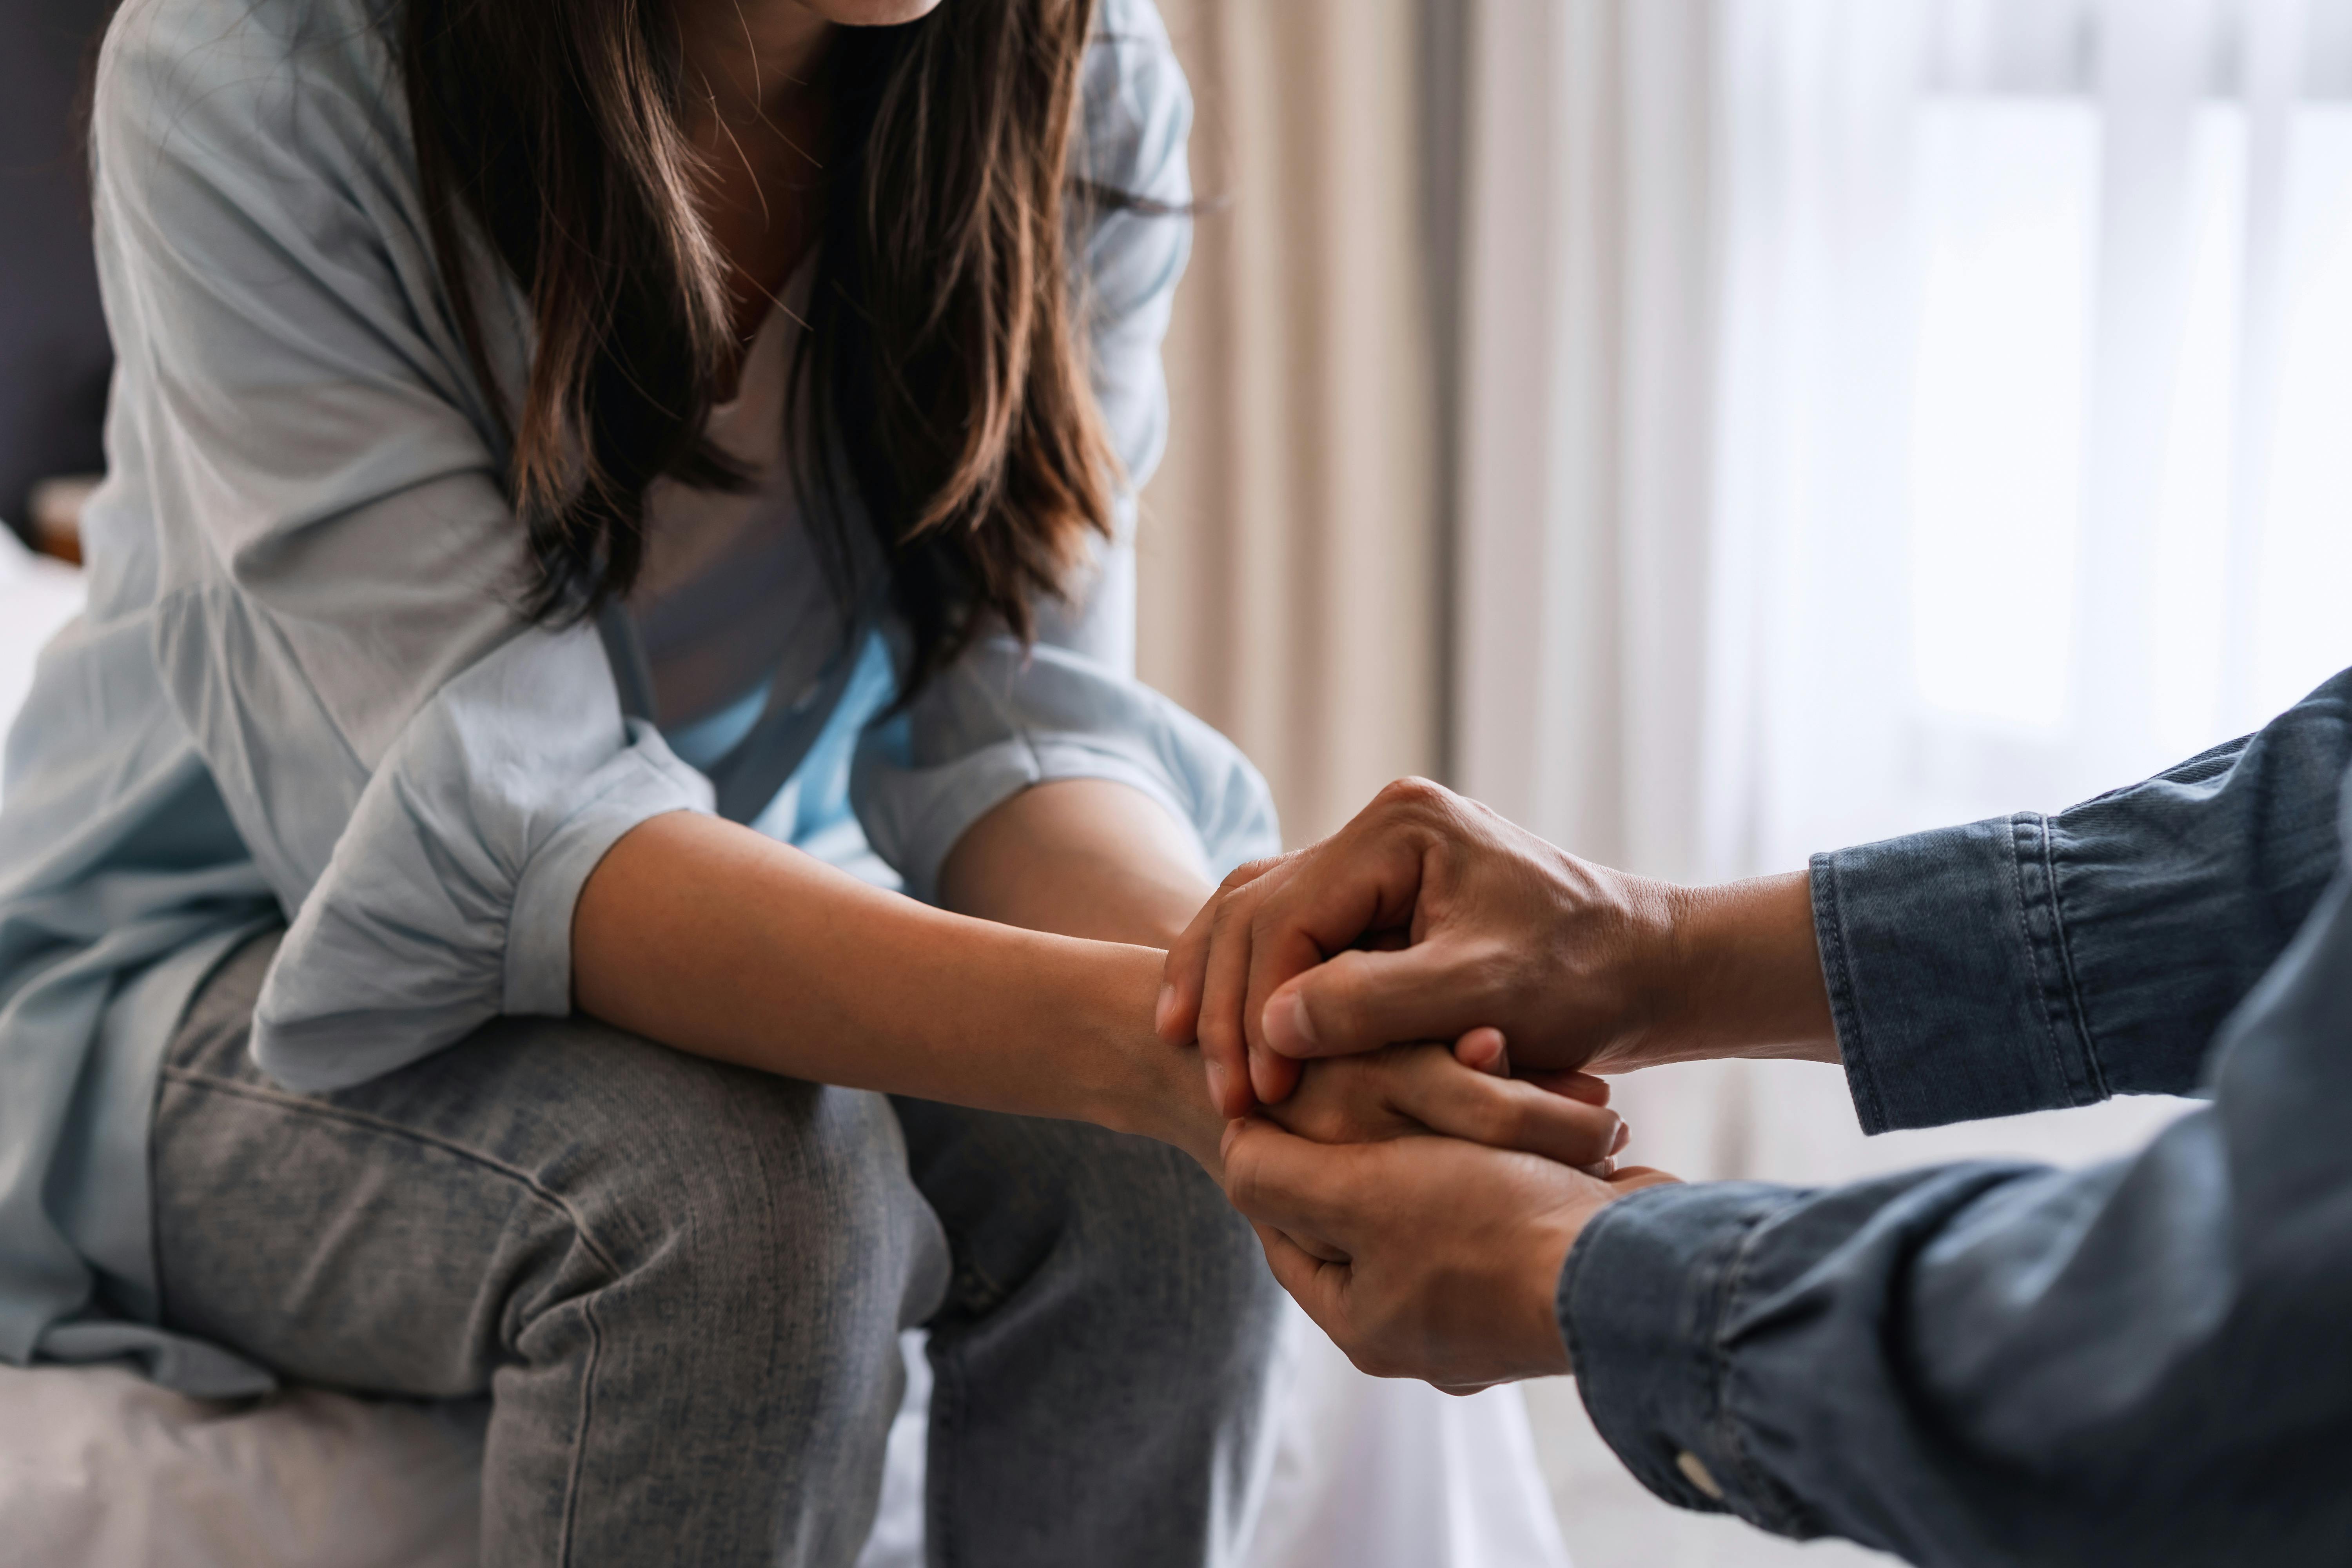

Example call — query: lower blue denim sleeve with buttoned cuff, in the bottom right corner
[1559,780,2352,1568]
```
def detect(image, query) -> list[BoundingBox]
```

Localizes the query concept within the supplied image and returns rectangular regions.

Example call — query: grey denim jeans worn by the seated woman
[153,938,1277,1568]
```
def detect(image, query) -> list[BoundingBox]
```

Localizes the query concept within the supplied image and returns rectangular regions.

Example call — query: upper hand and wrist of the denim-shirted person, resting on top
[1155,780,1835,1117]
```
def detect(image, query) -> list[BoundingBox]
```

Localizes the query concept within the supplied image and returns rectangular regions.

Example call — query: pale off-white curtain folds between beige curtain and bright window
[1454,0,1717,875]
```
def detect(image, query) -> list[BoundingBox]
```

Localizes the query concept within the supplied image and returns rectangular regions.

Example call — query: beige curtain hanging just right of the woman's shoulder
[1138,0,1444,844]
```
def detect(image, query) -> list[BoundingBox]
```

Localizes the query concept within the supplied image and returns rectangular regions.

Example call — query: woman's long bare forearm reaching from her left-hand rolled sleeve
[572,813,1223,1161]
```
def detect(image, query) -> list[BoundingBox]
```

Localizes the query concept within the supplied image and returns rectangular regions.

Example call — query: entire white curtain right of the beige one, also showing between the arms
[1456,0,2352,1176]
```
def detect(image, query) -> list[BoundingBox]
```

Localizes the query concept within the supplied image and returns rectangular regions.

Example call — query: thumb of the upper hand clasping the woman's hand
[1261,940,1494,1058]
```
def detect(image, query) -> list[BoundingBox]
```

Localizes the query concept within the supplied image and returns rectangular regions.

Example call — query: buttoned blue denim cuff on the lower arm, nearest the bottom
[1557,1182,1811,1535]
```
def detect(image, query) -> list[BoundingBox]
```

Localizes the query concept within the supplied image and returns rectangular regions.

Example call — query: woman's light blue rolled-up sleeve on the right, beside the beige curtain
[851,0,1279,898]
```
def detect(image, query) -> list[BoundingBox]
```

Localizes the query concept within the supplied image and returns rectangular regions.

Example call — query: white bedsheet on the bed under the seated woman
[0,529,1569,1568]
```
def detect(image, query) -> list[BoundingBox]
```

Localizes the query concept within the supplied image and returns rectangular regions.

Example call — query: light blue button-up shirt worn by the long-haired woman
[0,0,1275,1392]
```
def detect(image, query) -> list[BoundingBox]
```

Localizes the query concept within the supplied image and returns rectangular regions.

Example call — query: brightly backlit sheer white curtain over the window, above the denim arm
[1705,0,2352,872]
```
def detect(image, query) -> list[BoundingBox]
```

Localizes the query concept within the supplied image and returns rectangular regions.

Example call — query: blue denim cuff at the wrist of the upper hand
[1813,811,2107,1133]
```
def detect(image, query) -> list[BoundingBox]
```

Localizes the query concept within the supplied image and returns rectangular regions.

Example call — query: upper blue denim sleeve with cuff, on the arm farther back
[1813,670,2352,1133]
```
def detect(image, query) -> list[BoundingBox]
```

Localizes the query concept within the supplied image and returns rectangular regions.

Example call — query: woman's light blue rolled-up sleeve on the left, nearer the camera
[94,5,710,1089]
